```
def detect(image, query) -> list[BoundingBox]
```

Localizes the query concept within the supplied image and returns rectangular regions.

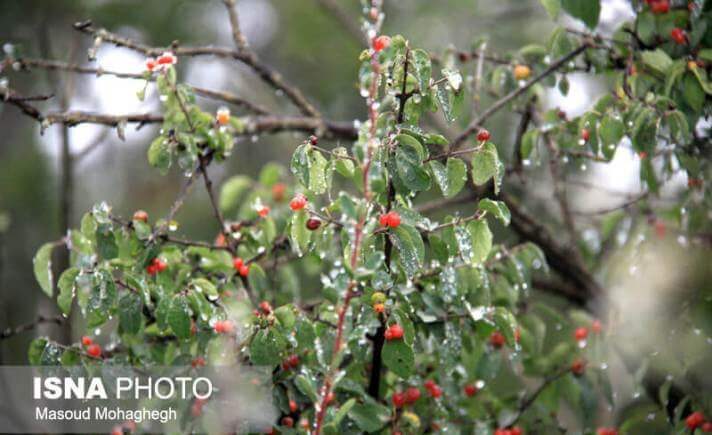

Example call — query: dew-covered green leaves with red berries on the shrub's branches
[28,0,712,433]
